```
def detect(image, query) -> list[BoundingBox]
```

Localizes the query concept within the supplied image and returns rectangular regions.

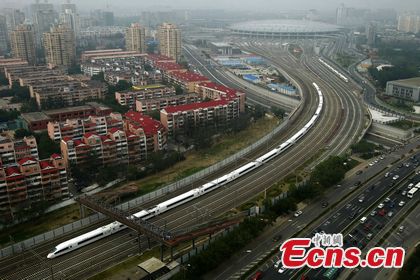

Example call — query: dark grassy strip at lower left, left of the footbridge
[0,204,80,246]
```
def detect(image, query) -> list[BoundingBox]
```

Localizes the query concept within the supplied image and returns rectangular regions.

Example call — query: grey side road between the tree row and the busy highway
[210,137,420,280]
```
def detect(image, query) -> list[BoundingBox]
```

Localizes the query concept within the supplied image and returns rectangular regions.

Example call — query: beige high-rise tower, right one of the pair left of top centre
[157,23,182,61]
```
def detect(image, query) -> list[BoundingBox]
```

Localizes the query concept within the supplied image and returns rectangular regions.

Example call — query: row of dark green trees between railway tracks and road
[174,157,347,279]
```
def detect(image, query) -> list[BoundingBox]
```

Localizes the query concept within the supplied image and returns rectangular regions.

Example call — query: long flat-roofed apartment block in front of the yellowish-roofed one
[136,93,201,113]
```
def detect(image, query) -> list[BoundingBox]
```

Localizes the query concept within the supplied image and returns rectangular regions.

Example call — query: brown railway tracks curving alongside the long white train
[0,40,364,279]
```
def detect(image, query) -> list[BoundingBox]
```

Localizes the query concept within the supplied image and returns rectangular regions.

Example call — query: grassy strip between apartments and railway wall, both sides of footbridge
[0,118,278,246]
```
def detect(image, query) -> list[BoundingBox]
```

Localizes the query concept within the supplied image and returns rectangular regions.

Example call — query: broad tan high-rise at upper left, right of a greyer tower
[44,25,76,66]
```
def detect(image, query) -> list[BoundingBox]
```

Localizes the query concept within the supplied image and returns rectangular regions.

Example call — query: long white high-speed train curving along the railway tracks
[47,83,324,259]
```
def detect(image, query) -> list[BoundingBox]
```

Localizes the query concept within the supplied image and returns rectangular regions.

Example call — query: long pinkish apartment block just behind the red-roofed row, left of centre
[48,113,123,141]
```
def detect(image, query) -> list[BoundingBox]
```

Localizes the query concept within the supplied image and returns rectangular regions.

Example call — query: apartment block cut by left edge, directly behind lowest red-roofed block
[0,134,39,165]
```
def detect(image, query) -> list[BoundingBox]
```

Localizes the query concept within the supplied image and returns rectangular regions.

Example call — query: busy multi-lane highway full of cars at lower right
[264,148,420,279]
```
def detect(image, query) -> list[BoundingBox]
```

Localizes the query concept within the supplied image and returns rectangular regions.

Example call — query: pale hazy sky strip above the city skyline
[0,0,420,11]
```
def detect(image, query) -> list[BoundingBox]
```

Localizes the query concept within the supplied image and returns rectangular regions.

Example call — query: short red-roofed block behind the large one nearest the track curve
[196,82,246,113]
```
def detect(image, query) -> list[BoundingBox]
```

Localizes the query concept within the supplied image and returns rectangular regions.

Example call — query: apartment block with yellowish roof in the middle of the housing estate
[115,85,175,109]
